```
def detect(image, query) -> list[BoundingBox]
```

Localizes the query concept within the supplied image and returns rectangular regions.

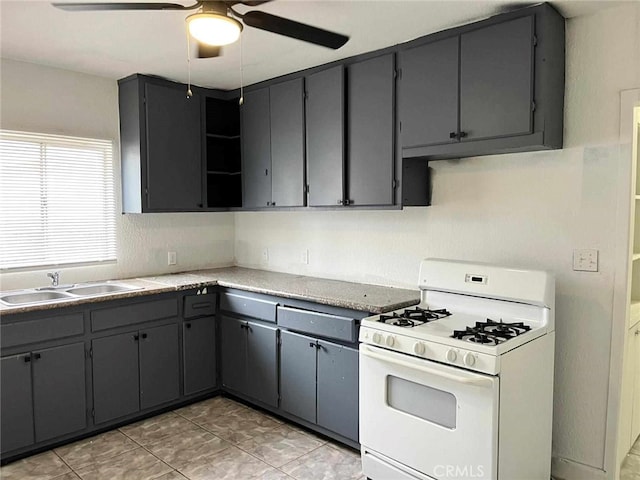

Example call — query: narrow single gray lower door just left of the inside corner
[182,317,216,395]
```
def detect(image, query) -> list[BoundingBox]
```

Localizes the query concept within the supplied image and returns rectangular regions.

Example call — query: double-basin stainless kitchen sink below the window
[0,282,141,307]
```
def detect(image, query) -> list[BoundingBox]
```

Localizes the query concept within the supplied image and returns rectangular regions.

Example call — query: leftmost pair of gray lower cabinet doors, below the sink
[2,342,87,452]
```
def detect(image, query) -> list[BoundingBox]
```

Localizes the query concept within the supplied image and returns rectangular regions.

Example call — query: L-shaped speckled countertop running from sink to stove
[0,267,420,315]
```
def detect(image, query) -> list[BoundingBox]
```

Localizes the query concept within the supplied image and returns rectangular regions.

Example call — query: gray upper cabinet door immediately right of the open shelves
[240,88,271,208]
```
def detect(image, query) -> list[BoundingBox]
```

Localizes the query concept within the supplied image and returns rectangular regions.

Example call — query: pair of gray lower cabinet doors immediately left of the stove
[280,330,359,441]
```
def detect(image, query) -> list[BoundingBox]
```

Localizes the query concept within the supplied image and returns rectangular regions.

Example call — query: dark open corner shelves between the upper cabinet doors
[205,97,242,208]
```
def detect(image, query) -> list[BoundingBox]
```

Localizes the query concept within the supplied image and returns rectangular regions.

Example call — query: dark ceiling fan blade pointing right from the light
[242,11,349,50]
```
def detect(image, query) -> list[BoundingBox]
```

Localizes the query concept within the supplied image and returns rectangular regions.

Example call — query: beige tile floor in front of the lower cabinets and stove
[0,397,364,480]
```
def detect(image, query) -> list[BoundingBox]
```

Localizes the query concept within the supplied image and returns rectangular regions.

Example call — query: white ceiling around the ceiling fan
[0,0,635,89]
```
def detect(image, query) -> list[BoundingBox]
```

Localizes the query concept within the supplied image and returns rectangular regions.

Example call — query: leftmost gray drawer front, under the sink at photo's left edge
[0,313,84,348]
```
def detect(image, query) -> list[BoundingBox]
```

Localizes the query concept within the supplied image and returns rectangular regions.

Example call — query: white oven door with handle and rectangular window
[360,344,499,480]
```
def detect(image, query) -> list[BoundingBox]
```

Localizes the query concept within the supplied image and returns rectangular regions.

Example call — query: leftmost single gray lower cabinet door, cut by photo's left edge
[0,353,34,453]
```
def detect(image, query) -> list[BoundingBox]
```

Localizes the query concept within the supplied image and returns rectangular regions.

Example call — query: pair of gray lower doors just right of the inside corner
[220,315,278,407]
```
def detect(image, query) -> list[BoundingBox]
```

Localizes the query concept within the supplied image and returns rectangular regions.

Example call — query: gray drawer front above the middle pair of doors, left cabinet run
[91,298,178,332]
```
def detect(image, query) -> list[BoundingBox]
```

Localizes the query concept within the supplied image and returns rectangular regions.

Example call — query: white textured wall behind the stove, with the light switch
[235,3,640,478]
